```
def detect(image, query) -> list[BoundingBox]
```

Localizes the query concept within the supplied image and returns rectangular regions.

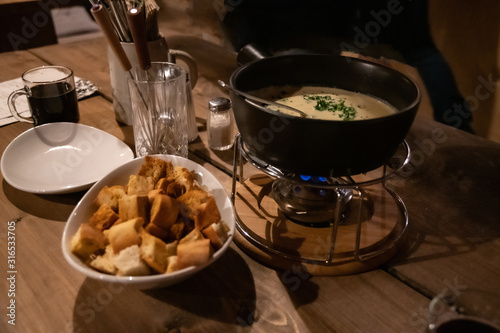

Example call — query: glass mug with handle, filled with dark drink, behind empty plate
[7,66,80,126]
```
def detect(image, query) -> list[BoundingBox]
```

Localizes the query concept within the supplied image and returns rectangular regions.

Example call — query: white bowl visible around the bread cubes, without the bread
[62,155,235,289]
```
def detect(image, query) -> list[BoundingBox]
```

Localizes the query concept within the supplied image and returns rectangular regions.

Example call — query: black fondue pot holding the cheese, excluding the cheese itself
[230,54,420,177]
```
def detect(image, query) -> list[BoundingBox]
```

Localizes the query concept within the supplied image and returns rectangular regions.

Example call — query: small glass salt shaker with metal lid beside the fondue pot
[207,97,234,150]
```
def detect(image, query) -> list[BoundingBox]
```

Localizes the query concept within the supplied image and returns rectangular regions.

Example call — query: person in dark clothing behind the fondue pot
[222,0,473,133]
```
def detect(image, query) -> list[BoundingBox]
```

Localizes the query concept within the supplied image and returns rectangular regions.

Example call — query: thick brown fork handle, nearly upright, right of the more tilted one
[127,8,151,70]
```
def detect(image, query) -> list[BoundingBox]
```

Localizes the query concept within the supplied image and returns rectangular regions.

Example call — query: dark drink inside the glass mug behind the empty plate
[28,82,80,126]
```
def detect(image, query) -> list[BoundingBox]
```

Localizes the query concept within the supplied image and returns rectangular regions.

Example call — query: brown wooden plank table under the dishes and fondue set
[0,24,500,333]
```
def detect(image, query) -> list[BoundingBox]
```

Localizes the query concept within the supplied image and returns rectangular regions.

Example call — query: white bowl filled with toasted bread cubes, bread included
[62,155,235,289]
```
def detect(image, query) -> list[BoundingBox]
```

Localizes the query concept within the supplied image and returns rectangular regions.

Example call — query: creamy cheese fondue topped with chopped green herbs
[253,86,397,121]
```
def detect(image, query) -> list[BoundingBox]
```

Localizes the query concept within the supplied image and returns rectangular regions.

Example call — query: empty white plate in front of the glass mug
[1,123,134,194]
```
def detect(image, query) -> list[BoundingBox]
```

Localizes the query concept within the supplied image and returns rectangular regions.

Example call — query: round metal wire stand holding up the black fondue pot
[231,134,410,275]
